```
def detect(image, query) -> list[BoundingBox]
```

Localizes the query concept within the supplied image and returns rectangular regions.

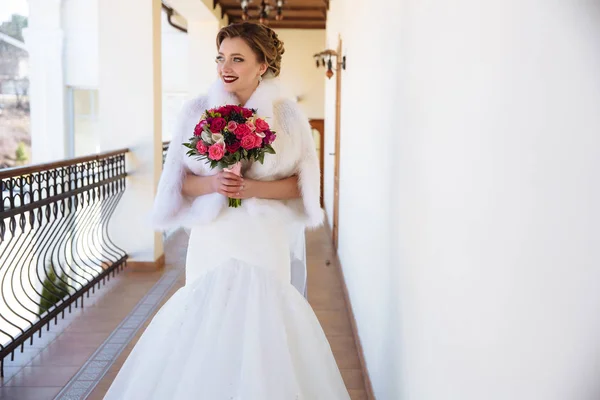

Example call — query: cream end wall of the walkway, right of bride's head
[277,29,326,119]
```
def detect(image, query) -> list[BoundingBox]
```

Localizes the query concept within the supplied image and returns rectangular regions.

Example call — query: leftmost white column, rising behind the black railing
[24,0,66,163]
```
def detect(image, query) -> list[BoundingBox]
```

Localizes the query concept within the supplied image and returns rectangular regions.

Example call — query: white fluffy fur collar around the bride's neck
[208,78,284,119]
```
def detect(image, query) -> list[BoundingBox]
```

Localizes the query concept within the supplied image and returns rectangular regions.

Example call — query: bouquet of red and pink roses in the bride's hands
[183,105,276,207]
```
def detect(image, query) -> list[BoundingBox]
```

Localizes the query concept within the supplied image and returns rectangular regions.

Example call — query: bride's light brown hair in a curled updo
[217,22,285,76]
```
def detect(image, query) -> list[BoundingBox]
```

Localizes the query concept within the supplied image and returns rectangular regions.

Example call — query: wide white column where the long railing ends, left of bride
[98,0,163,262]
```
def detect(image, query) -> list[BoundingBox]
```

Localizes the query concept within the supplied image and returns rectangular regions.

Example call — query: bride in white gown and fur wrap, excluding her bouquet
[105,23,350,400]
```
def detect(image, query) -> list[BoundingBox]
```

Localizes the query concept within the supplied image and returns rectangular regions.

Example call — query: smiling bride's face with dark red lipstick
[217,37,267,93]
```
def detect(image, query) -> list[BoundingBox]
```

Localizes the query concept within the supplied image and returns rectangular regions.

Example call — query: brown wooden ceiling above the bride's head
[213,0,329,29]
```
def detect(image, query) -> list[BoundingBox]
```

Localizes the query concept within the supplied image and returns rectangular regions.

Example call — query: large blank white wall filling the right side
[326,0,600,400]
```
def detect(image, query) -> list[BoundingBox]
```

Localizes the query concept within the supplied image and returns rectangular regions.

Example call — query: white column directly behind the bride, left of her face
[188,20,220,97]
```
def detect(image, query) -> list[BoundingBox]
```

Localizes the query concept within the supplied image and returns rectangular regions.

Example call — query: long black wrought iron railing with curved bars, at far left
[0,150,127,376]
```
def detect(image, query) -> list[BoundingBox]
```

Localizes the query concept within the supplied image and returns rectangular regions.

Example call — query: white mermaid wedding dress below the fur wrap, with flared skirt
[105,205,350,400]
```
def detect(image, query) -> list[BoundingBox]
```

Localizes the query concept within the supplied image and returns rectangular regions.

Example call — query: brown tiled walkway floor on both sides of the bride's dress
[0,229,367,400]
